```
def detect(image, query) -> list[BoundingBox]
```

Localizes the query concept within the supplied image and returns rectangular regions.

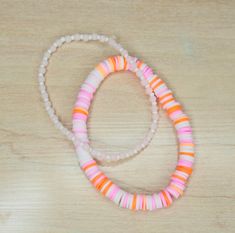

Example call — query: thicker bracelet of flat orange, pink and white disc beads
[73,56,194,210]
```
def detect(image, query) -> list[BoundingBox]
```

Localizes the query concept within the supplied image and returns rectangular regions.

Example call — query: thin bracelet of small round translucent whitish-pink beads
[38,34,158,161]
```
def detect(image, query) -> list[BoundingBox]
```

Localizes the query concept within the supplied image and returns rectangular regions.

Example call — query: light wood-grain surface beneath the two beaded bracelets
[0,0,235,233]
